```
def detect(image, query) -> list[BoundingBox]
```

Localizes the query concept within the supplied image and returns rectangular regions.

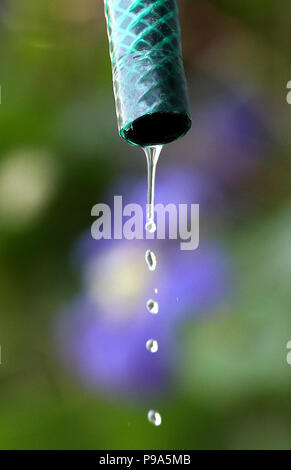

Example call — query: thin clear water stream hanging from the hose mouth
[144,145,163,233]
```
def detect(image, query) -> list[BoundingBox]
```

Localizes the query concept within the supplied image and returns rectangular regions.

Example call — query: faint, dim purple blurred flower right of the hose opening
[181,93,274,185]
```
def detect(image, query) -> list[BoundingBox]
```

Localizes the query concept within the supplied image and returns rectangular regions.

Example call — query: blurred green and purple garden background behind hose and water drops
[0,0,291,449]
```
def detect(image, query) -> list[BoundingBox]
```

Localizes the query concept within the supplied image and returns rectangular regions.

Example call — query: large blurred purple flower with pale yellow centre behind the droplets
[58,169,234,397]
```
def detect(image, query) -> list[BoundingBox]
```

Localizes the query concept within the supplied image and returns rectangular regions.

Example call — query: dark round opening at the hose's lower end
[123,113,191,147]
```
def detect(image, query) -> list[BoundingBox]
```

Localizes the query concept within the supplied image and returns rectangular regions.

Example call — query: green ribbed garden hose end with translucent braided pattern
[105,0,191,147]
